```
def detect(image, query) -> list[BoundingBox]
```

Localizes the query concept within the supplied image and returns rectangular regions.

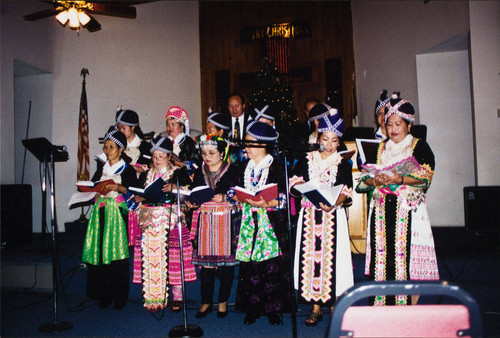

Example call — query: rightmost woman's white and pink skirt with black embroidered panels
[365,194,439,305]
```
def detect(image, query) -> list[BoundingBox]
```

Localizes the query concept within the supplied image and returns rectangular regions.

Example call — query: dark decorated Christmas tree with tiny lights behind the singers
[248,57,297,139]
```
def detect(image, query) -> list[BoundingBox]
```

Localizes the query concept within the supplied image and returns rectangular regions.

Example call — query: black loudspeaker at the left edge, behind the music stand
[1,184,33,244]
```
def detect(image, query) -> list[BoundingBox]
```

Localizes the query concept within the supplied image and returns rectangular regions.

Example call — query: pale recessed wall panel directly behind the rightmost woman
[417,51,475,226]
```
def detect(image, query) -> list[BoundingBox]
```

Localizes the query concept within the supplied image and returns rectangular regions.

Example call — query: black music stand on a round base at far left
[22,137,73,332]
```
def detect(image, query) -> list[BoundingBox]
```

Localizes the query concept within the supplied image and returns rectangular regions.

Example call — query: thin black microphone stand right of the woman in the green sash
[276,142,297,338]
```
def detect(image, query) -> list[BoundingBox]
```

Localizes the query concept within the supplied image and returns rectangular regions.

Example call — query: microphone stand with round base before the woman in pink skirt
[168,176,203,337]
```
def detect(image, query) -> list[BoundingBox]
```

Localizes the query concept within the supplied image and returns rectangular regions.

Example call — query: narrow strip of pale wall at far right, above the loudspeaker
[470,1,500,185]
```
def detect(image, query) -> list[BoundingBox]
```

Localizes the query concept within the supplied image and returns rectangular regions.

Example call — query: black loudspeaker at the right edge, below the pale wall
[464,186,500,232]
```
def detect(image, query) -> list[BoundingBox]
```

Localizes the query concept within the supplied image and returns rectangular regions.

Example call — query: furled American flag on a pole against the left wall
[77,68,90,181]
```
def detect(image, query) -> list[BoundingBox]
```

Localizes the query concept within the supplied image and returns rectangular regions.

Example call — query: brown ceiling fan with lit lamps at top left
[24,0,145,32]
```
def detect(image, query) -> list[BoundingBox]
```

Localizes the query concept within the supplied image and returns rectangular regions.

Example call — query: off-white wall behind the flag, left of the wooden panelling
[2,1,201,229]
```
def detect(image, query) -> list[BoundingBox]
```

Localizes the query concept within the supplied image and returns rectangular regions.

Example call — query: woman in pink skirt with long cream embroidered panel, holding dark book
[136,136,196,312]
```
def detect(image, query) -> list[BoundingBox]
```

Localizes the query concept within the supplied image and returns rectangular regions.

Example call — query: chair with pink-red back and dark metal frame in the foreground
[327,281,483,337]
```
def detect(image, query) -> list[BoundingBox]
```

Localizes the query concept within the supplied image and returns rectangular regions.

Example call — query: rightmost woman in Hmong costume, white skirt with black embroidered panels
[356,94,439,305]
